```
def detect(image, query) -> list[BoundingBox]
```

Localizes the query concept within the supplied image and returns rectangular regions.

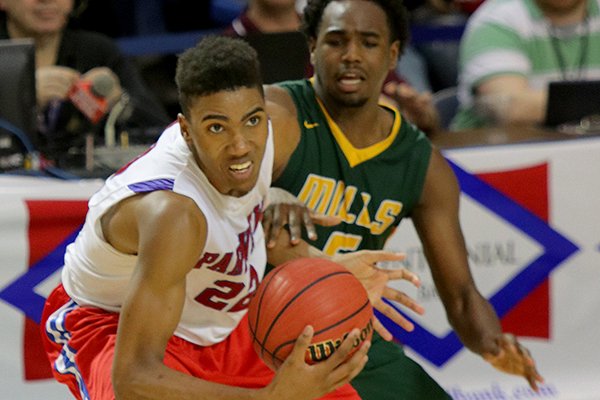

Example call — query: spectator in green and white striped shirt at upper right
[452,0,600,129]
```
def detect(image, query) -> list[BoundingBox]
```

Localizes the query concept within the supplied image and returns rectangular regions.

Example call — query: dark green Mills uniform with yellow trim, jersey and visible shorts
[273,80,450,400]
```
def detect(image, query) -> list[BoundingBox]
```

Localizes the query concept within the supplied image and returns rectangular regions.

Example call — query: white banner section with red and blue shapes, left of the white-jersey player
[0,176,101,400]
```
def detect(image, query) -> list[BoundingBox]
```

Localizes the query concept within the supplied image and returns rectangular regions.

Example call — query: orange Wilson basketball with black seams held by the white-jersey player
[248,258,373,370]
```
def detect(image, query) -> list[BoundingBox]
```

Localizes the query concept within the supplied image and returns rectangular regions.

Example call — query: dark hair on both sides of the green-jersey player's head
[301,0,409,50]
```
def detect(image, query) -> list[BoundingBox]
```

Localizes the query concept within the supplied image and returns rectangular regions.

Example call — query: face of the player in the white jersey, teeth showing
[178,88,268,197]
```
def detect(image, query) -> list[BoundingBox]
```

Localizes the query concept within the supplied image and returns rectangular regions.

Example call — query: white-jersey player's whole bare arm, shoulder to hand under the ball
[103,191,367,400]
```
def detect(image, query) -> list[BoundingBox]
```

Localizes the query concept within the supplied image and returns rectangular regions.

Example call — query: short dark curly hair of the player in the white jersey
[175,35,263,117]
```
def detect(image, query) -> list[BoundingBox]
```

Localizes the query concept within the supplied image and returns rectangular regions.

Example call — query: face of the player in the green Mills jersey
[311,0,399,107]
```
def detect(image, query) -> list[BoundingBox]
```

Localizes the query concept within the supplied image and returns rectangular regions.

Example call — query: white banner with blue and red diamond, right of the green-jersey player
[387,138,600,400]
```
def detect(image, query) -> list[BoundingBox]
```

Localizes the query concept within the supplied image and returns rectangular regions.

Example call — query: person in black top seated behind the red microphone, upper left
[0,0,170,167]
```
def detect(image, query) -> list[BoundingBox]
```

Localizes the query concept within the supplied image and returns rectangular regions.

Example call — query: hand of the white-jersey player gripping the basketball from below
[260,326,371,400]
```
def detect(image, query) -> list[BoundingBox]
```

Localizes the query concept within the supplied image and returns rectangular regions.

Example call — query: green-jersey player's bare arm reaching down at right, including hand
[412,149,541,389]
